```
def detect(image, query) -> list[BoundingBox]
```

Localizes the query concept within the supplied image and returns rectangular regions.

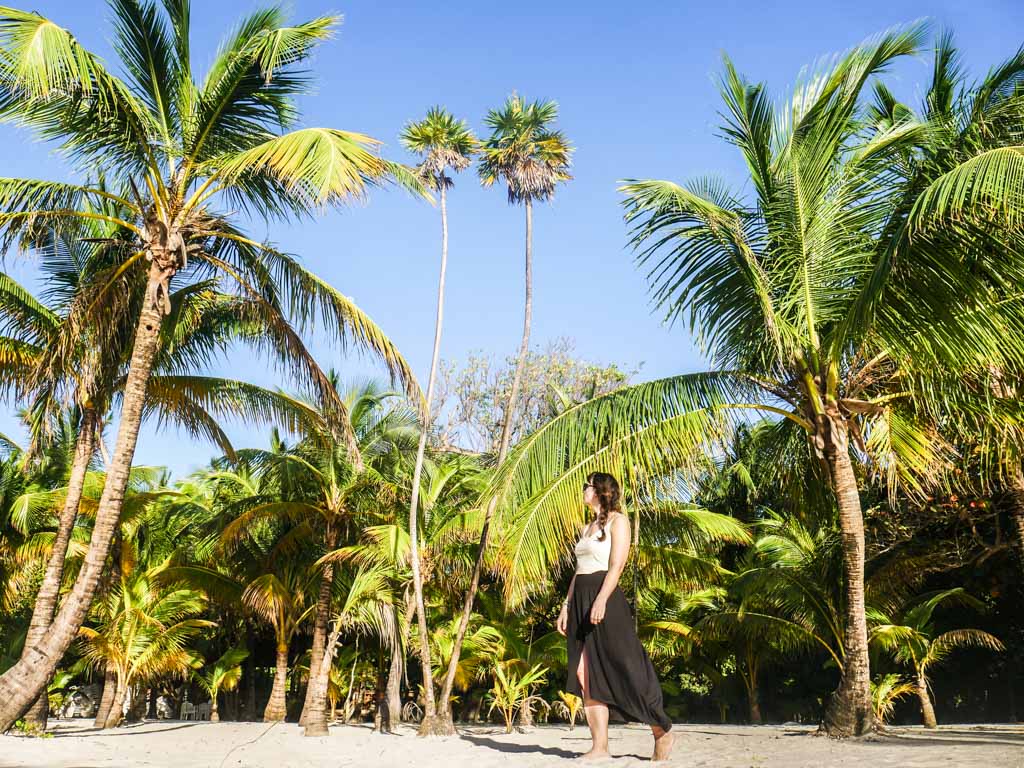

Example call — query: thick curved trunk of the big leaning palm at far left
[0,261,173,733]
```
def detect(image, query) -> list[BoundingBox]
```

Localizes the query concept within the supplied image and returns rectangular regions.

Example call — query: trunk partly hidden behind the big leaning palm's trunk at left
[22,408,97,730]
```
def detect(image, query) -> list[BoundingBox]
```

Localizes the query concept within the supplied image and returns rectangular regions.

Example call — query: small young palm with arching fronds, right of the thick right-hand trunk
[868,587,1004,728]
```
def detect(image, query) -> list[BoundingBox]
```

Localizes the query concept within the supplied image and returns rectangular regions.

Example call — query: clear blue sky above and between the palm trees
[0,0,1024,475]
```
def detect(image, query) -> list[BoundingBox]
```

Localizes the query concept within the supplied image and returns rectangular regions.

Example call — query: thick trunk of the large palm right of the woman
[822,414,874,736]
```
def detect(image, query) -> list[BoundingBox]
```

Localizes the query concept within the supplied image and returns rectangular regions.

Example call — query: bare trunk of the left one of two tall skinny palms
[411,183,447,736]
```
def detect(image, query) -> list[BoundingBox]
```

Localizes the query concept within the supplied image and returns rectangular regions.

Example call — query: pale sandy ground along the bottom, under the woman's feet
[0,721,1024,768]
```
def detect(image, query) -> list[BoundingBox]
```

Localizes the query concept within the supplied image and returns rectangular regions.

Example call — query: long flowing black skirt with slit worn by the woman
[565,570,672,730]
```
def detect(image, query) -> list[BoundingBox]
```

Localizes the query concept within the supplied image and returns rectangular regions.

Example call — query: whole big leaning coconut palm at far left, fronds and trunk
[0,0,413,731]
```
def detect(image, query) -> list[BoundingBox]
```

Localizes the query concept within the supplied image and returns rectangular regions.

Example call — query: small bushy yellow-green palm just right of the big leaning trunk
[80,565,215,728]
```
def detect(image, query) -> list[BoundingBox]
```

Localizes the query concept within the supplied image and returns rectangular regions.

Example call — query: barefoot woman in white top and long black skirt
[556,472,674,760]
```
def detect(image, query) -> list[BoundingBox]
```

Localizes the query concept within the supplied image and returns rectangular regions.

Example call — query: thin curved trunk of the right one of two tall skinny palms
[438,198,534,733]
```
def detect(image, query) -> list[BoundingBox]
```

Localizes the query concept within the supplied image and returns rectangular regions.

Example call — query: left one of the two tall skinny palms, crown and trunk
[401,106,478,737]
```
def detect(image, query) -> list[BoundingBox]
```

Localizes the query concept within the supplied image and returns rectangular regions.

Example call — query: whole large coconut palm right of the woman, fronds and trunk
[479,26,1024,734]
